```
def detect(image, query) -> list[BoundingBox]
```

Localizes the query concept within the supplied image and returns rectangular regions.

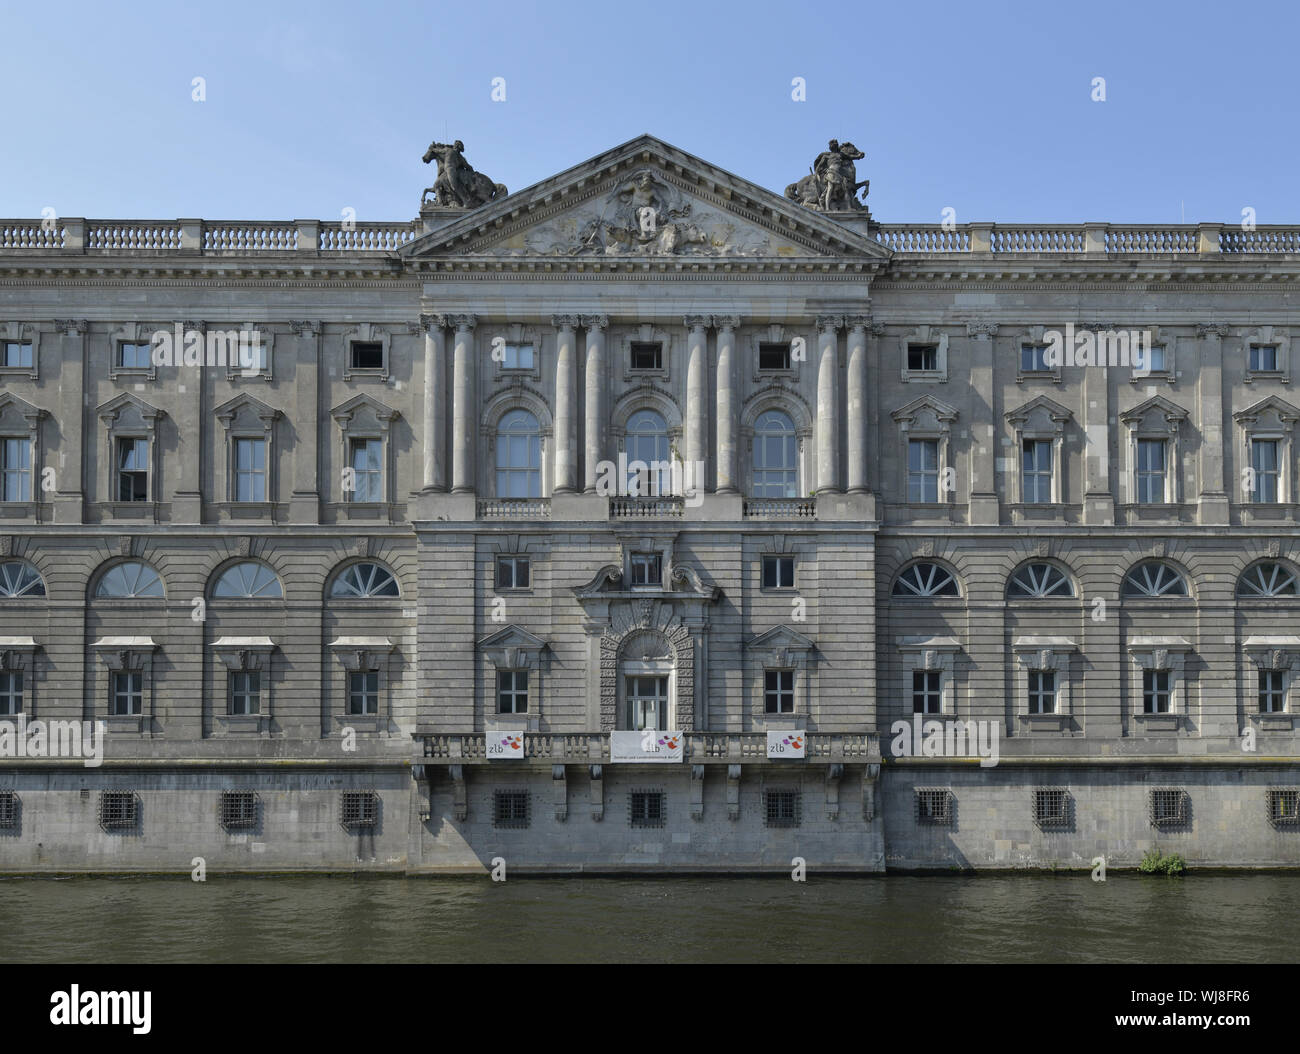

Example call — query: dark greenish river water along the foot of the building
[0,873,1300,963]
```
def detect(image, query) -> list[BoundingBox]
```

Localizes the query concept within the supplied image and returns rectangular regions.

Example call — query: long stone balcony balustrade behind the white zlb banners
[416,732,880,764]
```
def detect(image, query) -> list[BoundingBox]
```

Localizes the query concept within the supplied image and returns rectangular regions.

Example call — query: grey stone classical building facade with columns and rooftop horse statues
[0,136,1300,872]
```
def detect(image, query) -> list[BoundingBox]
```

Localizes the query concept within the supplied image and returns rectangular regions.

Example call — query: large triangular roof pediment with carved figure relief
[399,135,891,270]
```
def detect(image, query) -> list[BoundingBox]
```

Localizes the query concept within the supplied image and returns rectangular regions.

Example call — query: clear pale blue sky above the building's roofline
[0,0,1300,224]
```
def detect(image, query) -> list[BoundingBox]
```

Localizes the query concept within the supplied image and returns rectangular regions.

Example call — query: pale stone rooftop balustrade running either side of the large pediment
[0,217,1300,256]
